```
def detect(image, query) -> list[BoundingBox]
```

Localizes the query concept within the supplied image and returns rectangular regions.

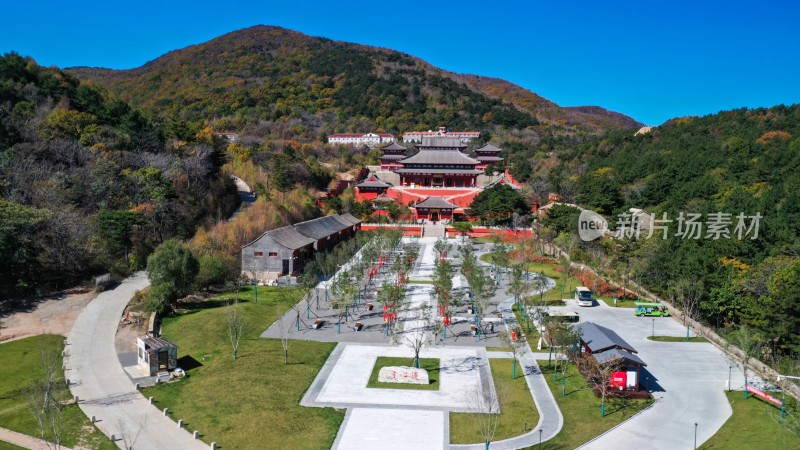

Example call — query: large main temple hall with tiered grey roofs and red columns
[394,137,483,187]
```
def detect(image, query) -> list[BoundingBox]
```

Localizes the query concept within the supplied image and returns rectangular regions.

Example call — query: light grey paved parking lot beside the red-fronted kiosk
[563,301,744,449]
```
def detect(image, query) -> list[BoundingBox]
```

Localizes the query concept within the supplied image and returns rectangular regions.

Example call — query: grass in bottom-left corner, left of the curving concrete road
[0,335,117,450]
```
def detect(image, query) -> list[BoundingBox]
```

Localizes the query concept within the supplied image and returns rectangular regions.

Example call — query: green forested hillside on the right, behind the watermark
[535,105,800,353]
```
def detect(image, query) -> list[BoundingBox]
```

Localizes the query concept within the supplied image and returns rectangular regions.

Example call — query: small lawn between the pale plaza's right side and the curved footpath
[450,359,539,444]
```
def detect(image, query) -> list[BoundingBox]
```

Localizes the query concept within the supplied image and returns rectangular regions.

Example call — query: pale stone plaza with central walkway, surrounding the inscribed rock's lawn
[288,238,563,449]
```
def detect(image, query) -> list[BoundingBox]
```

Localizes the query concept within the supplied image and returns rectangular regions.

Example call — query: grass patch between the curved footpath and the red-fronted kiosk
[538,360,652,450]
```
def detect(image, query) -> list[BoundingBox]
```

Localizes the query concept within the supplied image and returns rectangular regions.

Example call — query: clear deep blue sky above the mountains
[0,0,800,125]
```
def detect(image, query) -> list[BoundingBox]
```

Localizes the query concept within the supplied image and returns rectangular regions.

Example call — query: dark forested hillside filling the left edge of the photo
[0,53,237,298]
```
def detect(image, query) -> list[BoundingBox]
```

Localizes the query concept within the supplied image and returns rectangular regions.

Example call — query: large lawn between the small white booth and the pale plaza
[144,286,344,449]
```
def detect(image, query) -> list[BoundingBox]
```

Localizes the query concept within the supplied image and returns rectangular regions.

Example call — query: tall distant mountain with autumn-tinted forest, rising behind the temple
[69,26,640,140]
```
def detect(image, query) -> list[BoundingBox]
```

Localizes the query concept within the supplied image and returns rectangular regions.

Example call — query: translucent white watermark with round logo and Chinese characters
[578,210,763,242]
